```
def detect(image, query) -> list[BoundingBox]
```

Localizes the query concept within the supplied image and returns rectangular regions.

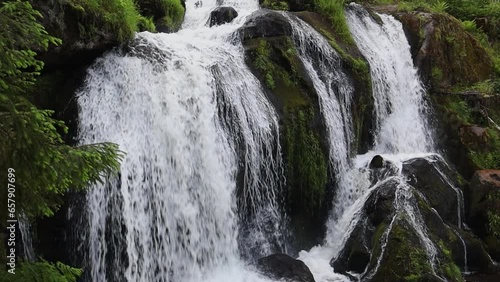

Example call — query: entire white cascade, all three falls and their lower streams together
[72,0,465,282]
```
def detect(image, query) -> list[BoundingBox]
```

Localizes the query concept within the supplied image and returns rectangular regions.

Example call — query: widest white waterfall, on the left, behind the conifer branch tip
[78,0,286,282]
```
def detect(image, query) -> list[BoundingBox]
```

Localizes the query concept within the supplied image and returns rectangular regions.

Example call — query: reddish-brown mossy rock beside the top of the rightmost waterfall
[396,12,493,89]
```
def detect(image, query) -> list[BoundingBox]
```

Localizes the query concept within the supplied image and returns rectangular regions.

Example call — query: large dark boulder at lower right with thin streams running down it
[330,156,500,281]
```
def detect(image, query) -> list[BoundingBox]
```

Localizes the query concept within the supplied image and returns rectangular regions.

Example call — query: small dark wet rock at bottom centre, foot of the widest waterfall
[257,254,314,282]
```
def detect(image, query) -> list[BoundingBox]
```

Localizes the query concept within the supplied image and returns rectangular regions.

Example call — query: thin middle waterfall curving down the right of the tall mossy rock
[283,13,354,175]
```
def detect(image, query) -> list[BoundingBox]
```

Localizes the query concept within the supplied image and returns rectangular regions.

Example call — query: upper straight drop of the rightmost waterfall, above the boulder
[346,5,434,154]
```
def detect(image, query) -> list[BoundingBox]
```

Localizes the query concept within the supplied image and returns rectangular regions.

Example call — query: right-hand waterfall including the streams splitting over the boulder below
[299,4,462,281]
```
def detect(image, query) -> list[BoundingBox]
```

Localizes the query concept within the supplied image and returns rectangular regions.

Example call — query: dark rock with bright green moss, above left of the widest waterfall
[31,0,140,67]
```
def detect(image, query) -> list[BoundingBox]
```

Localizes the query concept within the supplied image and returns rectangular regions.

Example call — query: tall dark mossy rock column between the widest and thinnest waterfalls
[240,10,332,250]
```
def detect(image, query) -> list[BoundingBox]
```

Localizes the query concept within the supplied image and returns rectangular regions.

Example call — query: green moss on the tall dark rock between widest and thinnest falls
[247,37,328,213]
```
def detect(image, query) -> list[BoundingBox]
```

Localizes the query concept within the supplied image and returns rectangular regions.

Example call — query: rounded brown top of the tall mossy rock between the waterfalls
[239,9,292,40]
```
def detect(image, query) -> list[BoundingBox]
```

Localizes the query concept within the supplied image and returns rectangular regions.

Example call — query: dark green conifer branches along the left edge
[0,1,121,281]
